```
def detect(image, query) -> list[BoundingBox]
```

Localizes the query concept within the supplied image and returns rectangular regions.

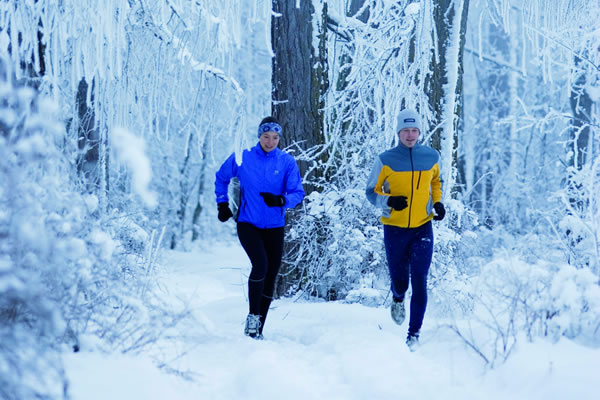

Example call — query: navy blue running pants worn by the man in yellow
[383,221,433,335]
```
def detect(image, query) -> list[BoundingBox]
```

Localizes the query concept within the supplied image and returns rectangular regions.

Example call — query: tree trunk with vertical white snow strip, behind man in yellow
[426,0,469,199]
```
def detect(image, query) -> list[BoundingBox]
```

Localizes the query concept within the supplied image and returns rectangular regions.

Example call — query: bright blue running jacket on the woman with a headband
[215,143,304,229]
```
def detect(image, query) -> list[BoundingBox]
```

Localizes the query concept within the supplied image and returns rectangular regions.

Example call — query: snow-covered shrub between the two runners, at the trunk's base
[286,189,388,300]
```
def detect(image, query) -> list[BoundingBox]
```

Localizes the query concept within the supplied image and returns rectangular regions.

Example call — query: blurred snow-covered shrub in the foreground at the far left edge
[0,81,72,399]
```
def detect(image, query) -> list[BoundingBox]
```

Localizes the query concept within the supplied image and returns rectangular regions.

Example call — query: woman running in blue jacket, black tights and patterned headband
[215,117,304,339]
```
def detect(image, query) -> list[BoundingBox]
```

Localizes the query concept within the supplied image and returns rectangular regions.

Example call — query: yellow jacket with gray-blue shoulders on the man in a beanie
[366,143,442,228]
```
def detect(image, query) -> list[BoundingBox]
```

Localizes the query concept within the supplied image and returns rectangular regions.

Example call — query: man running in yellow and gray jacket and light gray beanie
[366,110,446,351]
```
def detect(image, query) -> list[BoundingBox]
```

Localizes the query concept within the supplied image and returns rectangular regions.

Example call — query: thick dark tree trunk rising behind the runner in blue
[271,0,328,295]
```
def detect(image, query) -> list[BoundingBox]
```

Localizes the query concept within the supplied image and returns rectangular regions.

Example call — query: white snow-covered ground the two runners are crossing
[66,238,600,400]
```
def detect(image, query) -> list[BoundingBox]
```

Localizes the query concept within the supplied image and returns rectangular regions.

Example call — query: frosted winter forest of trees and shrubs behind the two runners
[0,0,600,399]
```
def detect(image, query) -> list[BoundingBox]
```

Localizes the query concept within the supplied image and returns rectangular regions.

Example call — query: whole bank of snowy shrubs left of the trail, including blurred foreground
[0,81,185,400]
